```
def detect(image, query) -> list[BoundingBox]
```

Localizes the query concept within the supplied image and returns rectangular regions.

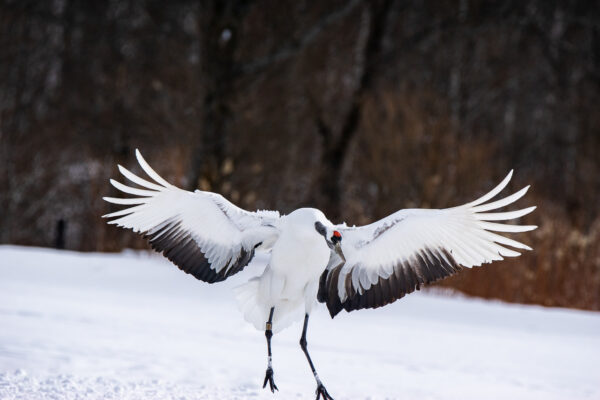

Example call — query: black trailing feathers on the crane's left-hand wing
[144,219,260,283]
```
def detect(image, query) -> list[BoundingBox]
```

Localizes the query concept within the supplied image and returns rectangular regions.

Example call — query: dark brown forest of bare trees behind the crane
[0,0,600,310]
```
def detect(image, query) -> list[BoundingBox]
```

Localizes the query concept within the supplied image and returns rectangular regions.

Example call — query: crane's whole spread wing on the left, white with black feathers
[104,150,279,283]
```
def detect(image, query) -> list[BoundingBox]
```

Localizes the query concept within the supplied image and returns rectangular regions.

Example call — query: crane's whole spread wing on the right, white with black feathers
[318,171,536,317]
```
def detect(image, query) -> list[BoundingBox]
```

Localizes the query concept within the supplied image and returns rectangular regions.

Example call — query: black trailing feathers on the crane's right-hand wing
[318,248,463,318]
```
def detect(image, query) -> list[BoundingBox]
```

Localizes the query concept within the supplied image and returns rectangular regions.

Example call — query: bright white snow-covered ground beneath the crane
[0,246,600,400]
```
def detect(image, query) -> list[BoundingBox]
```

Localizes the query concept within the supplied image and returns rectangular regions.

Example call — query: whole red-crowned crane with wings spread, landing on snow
[104,150,536,399]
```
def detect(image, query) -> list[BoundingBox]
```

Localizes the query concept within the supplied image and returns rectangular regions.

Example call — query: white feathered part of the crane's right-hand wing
[330,171,536,308]
